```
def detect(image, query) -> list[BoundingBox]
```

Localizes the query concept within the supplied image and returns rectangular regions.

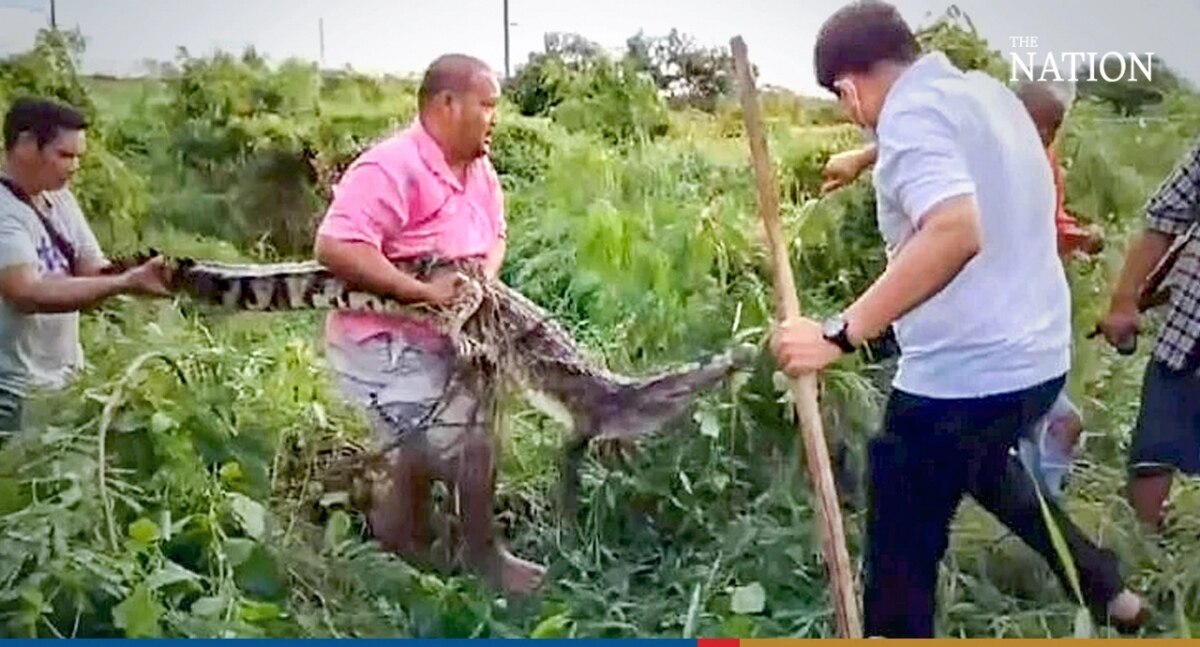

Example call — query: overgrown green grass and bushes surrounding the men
[0,25,1200,637]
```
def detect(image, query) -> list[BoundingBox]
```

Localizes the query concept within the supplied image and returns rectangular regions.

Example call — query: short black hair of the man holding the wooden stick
[812,0,920,94]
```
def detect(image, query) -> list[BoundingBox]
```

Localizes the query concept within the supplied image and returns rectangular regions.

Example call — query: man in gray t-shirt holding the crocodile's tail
[0,98,168,441]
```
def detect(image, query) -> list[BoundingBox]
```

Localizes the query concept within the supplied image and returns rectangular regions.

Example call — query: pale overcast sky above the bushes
[0,0,1200,95]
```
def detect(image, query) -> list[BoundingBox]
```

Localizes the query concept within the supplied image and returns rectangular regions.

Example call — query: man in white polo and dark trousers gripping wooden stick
[773,1,1145,637]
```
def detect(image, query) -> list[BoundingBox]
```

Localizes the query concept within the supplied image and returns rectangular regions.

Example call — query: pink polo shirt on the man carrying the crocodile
[317,120,506,343]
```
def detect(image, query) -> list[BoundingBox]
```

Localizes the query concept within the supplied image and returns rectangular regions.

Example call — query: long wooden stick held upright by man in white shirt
[730,36,863,639]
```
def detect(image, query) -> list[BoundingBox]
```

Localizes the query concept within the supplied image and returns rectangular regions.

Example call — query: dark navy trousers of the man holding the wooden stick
[863,377,1123,637]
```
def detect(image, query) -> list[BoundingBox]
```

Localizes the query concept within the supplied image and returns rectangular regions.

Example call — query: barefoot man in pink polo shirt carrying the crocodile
[316,54,545,593]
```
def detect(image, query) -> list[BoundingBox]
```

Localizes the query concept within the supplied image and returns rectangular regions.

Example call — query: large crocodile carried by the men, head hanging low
[106,250,757,508]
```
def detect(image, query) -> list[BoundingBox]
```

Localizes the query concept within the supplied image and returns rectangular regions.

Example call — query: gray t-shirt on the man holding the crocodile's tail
[0,185,103,395]
